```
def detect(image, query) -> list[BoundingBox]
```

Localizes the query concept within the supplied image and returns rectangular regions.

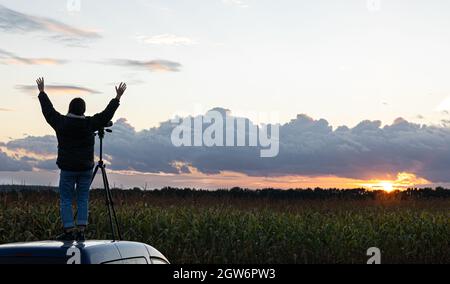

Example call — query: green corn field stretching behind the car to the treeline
[0,191,450,264]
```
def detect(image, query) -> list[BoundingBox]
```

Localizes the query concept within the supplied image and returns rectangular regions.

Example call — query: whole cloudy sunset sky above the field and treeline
[0,0,450,189]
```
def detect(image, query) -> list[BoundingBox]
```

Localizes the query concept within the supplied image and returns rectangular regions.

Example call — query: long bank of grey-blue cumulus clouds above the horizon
[2,112,450,182]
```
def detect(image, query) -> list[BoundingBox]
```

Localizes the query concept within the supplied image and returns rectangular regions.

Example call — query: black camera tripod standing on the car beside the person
[91,128,122,241]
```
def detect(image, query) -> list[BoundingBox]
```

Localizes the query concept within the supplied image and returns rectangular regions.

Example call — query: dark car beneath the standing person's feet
[0,241,169,264]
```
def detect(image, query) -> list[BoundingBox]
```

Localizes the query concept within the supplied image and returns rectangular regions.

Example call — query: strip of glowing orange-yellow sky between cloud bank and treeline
[0,170,436,192]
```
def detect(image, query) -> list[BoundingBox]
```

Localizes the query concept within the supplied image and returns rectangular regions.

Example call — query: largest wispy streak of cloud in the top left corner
[0,5,101,45]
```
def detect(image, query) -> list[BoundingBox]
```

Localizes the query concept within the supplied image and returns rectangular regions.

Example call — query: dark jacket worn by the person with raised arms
[39,92,119,171]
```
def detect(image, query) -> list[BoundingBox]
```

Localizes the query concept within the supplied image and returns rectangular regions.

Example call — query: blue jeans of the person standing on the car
[59,170,92,229]
